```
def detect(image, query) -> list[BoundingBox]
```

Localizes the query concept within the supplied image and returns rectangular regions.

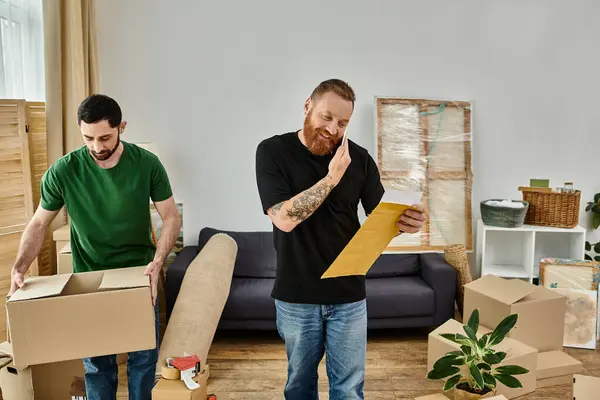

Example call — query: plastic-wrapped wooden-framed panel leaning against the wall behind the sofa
[376,97,473,252]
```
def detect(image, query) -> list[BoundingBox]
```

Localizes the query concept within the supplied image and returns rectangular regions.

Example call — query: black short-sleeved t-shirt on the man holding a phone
[256,132,384,304]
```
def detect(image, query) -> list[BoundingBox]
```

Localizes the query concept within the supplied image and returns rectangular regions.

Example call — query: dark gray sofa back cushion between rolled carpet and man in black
[198,228,277,278]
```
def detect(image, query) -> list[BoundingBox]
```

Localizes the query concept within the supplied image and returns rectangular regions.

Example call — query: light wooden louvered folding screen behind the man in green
[0,100,51,341]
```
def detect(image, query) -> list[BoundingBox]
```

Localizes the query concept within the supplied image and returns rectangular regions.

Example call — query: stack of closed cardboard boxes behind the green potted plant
[427,275,583,399]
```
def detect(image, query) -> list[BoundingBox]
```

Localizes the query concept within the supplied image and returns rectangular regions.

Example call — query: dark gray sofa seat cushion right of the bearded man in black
[367,276,435,318]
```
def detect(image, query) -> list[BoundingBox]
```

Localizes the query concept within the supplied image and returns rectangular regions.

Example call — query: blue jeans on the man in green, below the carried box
[83,299,159,400]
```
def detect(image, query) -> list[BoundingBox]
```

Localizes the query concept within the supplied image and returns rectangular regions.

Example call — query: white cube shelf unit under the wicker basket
[476,219,586,283]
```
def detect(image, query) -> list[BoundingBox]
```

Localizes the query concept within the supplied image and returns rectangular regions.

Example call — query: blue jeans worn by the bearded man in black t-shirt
[275,300,367,400]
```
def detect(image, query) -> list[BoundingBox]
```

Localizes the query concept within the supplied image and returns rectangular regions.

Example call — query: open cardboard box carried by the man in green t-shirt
[6,266,156,367]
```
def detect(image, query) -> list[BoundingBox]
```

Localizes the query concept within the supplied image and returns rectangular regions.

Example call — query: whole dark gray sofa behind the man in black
[166,228,456,330]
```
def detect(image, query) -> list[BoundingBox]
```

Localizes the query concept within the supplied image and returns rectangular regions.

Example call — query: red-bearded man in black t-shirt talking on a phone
[256,79,425,400]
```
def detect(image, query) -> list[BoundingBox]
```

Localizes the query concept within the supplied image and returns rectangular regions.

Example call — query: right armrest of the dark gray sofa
[419,253,456,325]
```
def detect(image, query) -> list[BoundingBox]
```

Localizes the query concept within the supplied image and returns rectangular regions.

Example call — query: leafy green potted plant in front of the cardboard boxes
[427,309,529,400]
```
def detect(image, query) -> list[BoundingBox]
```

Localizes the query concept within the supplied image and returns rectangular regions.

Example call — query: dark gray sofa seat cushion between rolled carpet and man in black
[221,278,276,320]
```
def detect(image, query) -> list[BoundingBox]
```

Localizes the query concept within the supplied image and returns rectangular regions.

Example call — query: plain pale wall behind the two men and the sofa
[96,0,600,255]
